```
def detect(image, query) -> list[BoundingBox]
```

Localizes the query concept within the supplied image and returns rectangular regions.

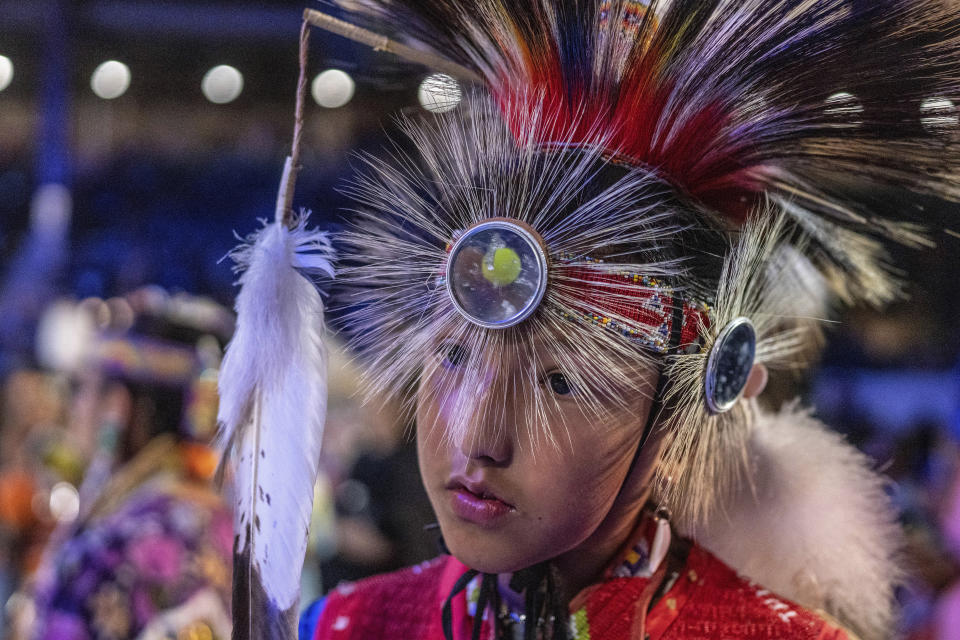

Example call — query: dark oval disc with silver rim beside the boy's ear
[704,318,757,413]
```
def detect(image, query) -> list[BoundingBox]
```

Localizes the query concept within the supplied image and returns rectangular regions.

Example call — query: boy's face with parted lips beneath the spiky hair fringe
[417,342,658,573]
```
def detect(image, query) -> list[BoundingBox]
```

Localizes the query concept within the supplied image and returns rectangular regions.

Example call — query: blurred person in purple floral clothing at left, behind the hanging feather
[3,288,233,640]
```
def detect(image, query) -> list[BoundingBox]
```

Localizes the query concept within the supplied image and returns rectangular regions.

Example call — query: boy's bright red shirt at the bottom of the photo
[313,519,855,640]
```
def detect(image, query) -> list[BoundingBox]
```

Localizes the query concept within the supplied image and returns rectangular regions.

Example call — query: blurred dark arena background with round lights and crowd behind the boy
[0,0,960,638]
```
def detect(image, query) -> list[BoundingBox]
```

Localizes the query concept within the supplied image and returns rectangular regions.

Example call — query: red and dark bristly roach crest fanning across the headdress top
[342,0,960,302]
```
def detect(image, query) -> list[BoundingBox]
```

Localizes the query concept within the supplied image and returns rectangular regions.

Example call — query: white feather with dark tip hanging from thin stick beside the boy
[218,25,333,640]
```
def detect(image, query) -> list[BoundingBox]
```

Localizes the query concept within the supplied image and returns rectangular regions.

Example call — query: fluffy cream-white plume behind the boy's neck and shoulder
[693,403,901,639]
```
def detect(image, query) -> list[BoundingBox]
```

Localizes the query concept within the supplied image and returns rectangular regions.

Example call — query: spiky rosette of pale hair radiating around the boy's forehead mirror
[339,97,727,449]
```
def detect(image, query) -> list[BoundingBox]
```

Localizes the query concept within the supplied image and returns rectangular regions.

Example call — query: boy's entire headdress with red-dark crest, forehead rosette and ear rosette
[332,0,960,520]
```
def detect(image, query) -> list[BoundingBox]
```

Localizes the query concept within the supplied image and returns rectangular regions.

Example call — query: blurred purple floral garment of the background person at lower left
[34,443,233,640]
